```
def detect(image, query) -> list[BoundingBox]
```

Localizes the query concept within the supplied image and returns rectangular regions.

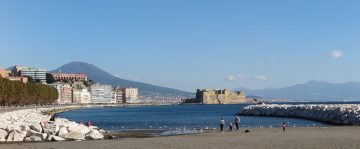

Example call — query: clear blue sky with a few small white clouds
[0,0,360,91]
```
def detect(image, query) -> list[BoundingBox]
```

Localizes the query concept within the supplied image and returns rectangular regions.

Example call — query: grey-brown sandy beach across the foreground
[0,127,360,149]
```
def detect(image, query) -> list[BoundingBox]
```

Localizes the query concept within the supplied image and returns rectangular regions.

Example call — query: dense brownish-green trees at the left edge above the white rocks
[0,77,58,106]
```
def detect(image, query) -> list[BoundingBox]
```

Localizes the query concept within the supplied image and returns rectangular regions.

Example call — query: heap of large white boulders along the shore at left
[0,108,104,142]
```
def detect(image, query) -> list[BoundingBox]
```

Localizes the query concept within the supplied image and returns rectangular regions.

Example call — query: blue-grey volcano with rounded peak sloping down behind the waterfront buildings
[51,62,195,99]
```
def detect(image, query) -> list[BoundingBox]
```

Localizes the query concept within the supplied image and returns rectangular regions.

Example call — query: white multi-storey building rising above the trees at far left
[11,66,47,83]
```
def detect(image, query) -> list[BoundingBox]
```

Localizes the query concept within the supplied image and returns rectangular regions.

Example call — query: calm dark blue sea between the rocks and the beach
[57,104,346,131]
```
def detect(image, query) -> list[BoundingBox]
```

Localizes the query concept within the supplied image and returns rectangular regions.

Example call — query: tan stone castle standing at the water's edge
[196,89,247,104]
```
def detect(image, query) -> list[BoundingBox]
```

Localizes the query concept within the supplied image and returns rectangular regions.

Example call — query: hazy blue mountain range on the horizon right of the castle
[235,81,360,101]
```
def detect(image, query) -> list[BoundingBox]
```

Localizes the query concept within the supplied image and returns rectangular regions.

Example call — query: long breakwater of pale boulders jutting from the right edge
[239,104,360,125]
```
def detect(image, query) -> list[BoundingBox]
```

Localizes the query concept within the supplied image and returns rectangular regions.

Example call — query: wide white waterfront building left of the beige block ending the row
[91,83,116,103]
